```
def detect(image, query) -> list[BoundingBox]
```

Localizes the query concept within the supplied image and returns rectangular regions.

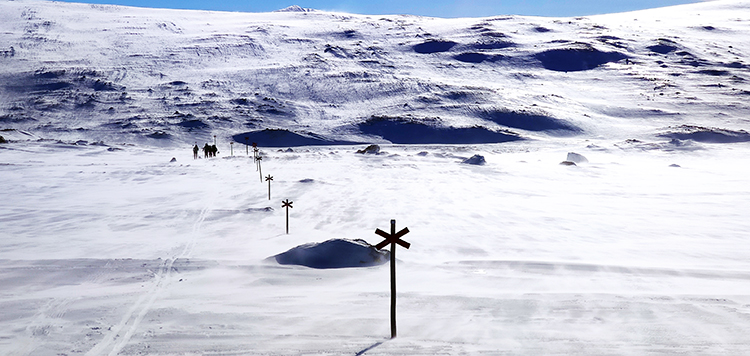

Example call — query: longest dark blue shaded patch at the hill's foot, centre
[357,116,522,144]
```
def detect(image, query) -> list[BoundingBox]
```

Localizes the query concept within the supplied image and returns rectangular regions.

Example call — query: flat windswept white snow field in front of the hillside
[0,139,750,355]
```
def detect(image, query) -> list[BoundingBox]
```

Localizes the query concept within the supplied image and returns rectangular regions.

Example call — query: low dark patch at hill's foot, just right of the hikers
[232,129,361,147]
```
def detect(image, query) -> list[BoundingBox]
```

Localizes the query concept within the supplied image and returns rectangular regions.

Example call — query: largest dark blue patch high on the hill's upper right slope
[534,44,628,72]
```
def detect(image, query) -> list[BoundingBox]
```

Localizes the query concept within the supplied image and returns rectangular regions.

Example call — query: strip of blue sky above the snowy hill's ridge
[55,0,701,17]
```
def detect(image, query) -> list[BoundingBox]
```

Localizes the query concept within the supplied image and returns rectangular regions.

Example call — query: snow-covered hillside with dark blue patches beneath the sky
[0,0,750,146]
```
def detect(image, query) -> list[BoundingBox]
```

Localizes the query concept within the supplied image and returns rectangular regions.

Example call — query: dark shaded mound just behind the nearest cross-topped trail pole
[273,239,390,269]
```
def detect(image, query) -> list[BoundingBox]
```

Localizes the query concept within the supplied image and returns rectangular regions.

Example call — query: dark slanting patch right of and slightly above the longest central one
[479,109,582,133]
